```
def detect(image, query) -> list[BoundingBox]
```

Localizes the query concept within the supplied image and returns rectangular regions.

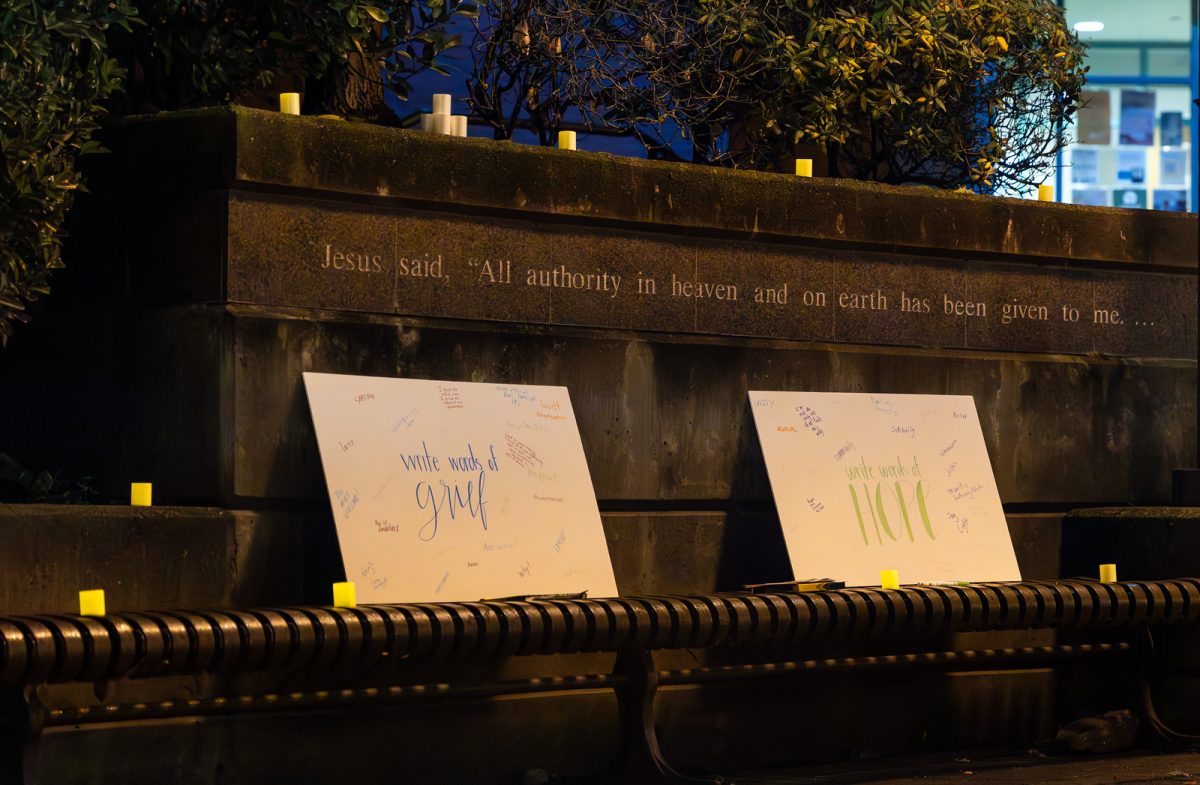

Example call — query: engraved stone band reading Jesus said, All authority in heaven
[228,194,1196,359]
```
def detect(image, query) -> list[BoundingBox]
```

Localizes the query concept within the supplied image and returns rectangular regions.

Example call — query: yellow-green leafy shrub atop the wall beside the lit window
[708,0,1086,191]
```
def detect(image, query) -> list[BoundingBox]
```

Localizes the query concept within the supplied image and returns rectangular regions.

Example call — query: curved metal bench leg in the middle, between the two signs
[614,652,720,785]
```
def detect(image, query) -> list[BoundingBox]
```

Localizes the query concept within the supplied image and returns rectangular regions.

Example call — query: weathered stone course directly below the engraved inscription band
[0,306,1195,509]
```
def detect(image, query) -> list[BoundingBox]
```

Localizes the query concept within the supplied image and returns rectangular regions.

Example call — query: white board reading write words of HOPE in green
[750,391,1021,586]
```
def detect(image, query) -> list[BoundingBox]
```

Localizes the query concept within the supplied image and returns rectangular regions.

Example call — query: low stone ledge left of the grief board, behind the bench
[0,504,307,615]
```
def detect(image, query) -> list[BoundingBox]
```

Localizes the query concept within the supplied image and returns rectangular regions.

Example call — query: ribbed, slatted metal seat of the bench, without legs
[0,579,1200,687]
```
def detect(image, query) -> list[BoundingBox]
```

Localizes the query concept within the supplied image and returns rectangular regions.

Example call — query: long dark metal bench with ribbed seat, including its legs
[0,579,1200,785]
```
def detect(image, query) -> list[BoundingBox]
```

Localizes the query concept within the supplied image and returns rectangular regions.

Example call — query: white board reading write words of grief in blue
[304,373,617,603]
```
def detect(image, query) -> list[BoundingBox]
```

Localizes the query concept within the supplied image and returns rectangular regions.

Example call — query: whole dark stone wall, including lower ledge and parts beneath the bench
[0,109,1196,783]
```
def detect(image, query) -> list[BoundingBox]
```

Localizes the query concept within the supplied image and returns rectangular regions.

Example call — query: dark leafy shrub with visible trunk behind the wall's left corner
[112,0,475,119]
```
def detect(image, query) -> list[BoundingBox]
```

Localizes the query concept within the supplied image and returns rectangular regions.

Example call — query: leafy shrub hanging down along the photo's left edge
[0,0,132,344]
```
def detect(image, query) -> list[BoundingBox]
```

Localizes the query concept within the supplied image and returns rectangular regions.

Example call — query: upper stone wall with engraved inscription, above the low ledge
[0,109,1196,511]
